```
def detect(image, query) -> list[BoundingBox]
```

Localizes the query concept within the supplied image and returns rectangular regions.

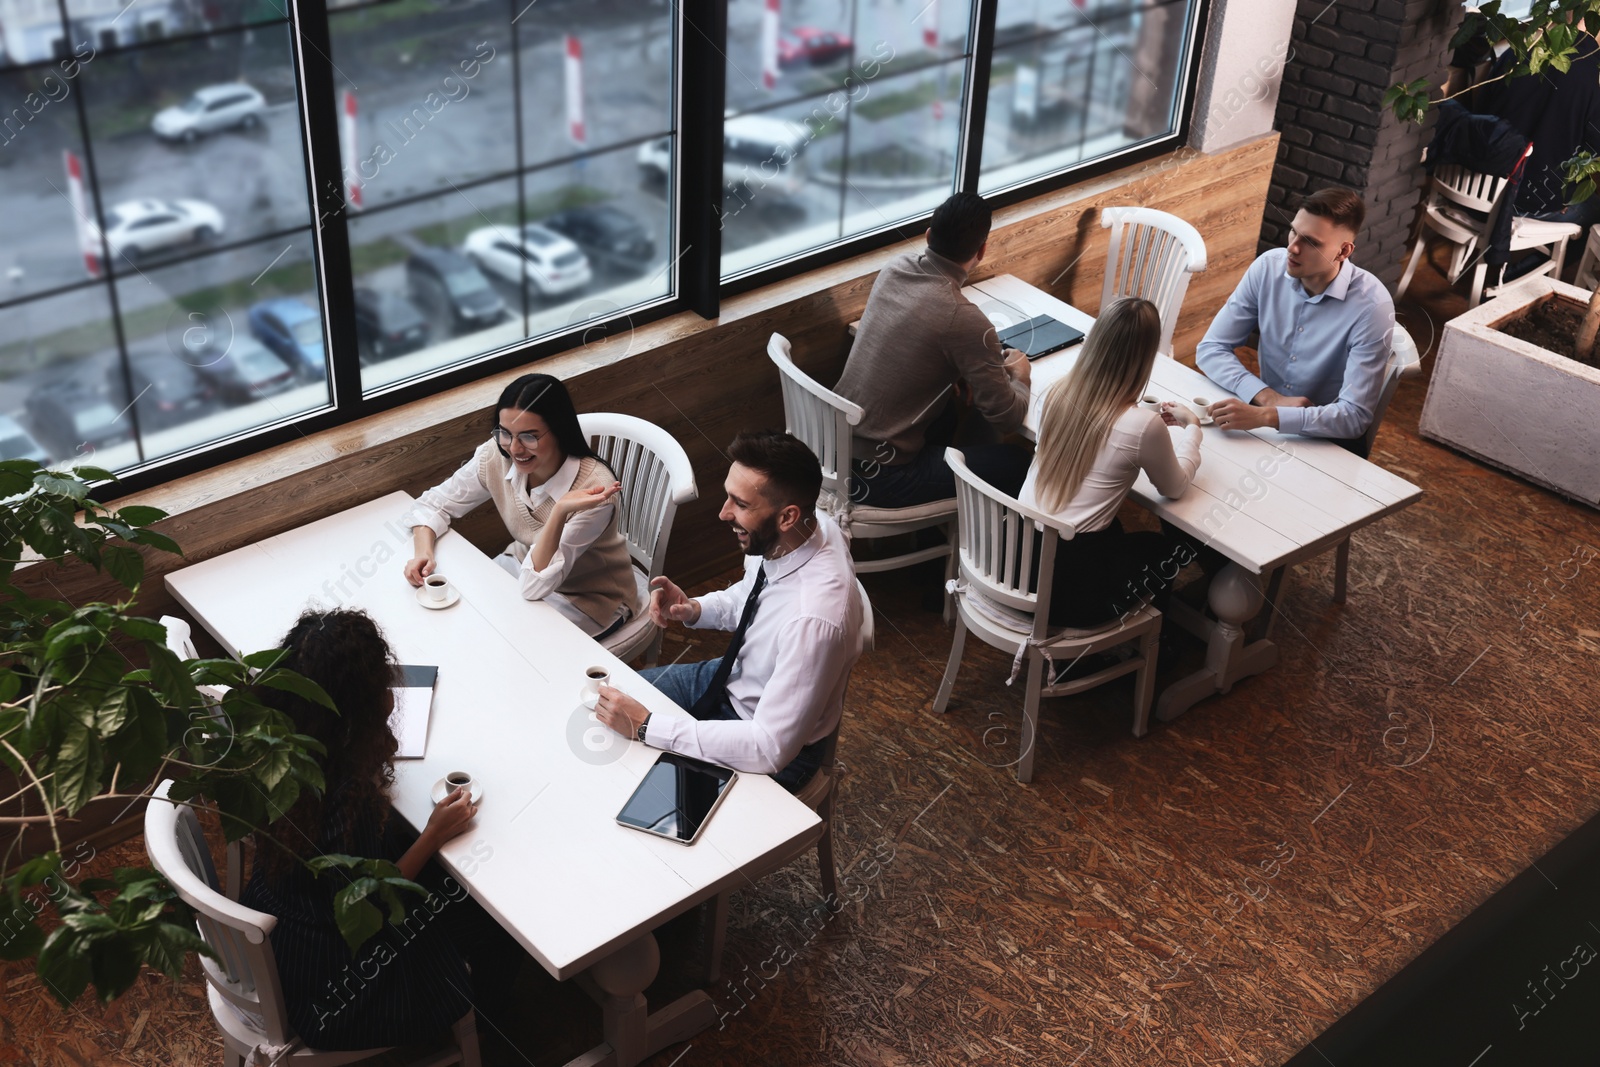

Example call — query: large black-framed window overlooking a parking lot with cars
[0,0,1200,485]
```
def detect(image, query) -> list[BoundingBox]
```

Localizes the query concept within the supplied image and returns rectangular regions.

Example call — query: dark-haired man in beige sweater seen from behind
[835,192,1029,507]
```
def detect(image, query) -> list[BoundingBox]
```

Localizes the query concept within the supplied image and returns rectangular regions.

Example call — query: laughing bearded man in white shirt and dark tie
[595,430,862,792]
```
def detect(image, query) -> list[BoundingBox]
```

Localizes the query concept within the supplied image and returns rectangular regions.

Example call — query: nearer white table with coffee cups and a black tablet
[166,493,821,1067]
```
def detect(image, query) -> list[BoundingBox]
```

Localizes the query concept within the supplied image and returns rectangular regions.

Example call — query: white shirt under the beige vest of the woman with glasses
[400,442,614,604]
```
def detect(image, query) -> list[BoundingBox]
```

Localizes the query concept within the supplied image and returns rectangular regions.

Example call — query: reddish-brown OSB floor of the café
[0,252,1600,1067]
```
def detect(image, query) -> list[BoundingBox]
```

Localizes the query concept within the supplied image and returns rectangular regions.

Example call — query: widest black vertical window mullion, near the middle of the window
[672,0,728,318]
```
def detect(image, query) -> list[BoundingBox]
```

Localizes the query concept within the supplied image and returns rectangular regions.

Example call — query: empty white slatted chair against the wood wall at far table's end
[1101,208,1205,355]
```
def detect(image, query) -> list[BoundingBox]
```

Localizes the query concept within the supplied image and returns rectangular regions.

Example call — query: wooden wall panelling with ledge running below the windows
[12,136,1277,630]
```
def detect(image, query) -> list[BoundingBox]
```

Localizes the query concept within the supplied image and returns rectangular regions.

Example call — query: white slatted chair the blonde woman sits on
[933,448,1162,782]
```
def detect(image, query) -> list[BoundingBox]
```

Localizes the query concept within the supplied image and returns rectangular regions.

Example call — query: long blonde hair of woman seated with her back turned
[1034,296,1162,512]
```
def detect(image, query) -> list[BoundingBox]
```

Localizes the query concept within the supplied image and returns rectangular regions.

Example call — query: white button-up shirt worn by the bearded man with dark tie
[645,512,861,774]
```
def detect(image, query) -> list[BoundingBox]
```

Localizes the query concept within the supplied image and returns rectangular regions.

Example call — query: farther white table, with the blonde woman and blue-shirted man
[965,275,1422,720]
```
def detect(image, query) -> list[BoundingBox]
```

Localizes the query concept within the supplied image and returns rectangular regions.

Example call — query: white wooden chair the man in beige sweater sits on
[766,333,955,576]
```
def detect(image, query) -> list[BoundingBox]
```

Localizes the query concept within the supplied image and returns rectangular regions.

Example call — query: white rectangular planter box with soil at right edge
[1421,277,1600,507]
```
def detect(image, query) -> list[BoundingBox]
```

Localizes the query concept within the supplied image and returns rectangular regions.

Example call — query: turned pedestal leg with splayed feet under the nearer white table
[566,934,717,1067]
